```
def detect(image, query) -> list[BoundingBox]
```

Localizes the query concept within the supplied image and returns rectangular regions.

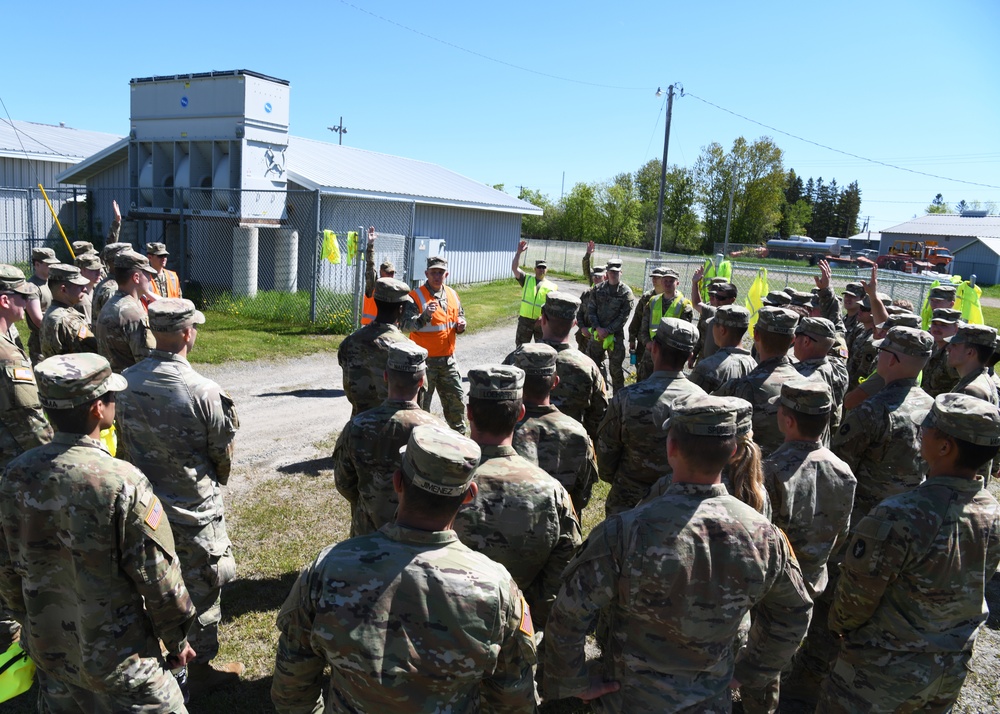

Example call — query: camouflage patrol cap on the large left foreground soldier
[35,352,128,409]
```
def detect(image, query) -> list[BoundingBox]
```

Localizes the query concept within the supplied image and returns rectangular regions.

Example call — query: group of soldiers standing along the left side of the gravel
[0,199,244,712]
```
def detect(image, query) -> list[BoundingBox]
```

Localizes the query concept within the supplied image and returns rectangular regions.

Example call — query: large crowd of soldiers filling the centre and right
[300,242,1000,712]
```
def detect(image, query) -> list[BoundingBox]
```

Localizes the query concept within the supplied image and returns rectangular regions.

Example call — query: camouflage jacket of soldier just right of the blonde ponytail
[764,441,858,599]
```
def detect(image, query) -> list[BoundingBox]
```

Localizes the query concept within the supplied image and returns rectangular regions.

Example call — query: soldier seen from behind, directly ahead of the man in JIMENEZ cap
[454,366,582,627]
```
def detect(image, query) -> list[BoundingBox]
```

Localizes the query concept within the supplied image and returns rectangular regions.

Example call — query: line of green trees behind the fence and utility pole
[512,137,861,253]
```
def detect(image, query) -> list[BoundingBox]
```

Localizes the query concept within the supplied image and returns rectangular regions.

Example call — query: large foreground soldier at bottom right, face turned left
[817,394,1000,713]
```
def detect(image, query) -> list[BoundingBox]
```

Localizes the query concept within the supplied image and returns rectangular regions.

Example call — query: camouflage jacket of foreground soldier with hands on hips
[544,483,812,712]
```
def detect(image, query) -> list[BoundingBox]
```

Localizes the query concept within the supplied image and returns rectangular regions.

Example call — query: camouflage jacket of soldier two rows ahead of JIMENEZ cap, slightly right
[513,403,597,513]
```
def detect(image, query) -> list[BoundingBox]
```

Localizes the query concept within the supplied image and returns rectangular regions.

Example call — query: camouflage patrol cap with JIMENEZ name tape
[399,424,482,496]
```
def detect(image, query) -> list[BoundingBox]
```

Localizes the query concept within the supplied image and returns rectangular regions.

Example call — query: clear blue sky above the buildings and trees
[0,0,1000,230]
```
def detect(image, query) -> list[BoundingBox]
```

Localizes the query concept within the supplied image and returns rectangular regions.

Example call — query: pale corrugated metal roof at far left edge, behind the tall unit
[0,118,121,164]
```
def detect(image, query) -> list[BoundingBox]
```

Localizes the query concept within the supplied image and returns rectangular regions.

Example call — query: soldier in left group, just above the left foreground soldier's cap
[41,263,97,359]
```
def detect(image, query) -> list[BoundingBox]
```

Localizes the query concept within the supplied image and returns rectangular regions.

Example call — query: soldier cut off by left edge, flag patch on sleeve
[0,265,52,653]
